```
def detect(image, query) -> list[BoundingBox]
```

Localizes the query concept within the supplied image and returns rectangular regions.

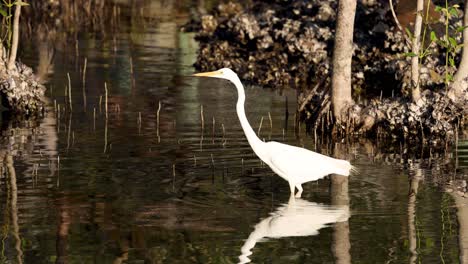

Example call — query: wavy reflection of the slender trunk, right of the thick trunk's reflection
[408,169,421,263]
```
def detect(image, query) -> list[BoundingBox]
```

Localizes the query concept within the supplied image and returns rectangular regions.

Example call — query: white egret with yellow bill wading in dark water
[194,68,353,197]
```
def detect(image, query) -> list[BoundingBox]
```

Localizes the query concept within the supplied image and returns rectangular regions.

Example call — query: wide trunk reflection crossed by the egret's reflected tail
[330,175,351,264]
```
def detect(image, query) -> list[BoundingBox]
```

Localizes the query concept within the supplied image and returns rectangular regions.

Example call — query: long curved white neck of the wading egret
[233,78,265,159]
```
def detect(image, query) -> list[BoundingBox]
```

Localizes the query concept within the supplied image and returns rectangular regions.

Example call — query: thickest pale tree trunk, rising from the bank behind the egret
[332,0,356,123]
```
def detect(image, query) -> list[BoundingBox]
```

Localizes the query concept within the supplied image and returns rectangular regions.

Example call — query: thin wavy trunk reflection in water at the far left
[5,154,23,263]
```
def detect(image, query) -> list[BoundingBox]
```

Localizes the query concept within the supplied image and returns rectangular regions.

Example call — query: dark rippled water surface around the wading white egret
[0,1,468,263]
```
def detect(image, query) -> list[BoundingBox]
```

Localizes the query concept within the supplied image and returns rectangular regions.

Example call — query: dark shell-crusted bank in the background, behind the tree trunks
[195,1,461,96]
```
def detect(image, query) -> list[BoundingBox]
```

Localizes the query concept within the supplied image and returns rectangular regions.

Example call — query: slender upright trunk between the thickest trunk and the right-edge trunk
[411,0,424,102]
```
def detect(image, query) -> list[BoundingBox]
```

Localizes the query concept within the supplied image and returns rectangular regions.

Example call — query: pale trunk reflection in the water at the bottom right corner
[452,193,468,264]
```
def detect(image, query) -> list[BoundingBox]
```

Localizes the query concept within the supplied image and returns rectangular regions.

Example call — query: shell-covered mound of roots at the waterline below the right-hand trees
[298,81,468,144]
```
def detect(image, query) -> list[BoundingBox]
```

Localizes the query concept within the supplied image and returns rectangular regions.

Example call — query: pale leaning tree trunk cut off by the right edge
[448,0,468,100]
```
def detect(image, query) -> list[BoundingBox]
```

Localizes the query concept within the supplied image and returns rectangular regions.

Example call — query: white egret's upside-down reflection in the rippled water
[239,196,349,263]
